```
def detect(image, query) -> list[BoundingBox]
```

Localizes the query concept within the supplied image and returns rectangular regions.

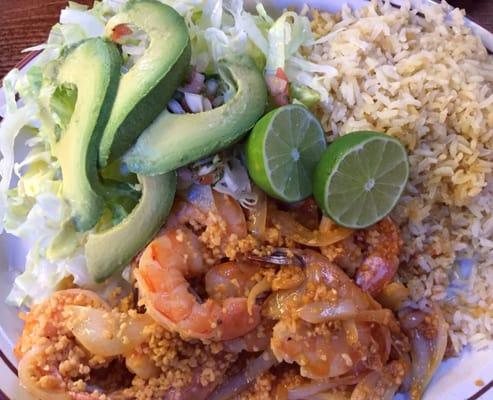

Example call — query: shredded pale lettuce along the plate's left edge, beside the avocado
[0,2,112,306]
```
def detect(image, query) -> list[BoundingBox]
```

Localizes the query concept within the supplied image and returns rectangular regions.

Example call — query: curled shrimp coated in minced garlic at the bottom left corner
[15,289,127,400]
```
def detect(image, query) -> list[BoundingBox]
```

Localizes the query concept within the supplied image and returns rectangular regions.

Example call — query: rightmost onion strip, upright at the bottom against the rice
[401,304,448,400]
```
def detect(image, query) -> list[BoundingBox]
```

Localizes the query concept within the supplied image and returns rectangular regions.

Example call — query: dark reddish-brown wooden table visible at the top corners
[0,0,493,77]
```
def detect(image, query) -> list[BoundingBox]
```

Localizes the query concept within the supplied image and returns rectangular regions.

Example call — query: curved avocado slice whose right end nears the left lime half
[123,56,267,175]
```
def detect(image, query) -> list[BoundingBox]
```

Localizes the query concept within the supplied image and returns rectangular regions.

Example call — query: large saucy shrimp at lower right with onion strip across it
[264,249,393,379]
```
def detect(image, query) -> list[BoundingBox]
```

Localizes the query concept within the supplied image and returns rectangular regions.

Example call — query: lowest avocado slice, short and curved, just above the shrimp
[85,172,176,282]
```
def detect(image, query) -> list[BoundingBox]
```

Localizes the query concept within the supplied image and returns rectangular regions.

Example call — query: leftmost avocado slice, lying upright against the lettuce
[53,38,121,231]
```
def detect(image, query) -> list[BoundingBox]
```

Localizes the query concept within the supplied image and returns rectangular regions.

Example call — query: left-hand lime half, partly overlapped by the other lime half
[246,104,326,202]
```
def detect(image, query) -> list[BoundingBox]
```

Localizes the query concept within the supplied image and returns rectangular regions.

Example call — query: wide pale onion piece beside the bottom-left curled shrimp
[65,306,151,357]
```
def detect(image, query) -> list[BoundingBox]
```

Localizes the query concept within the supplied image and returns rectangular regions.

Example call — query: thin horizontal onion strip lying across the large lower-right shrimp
[298,300,393,325]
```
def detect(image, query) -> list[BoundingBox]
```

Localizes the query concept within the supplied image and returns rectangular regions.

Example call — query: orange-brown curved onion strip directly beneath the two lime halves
[270,210,353,247]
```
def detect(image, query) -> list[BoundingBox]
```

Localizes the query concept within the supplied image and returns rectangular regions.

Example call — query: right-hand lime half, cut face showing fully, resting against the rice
[314,132,409,229]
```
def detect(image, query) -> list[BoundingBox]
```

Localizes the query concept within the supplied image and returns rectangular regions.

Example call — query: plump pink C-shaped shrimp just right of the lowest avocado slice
[135,227,260,340]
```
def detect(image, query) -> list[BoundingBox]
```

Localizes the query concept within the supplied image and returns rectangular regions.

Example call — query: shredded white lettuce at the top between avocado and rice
[161,0,337,103]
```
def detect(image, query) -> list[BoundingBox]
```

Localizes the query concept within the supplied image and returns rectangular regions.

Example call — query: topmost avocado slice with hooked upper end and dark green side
[99,0,191,167]
